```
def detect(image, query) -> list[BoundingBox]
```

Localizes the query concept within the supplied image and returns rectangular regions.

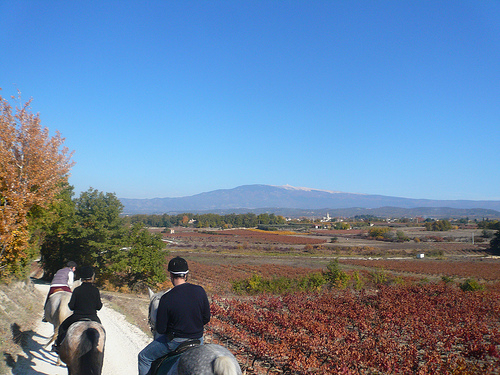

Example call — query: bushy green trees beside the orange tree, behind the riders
[41,188,166,286]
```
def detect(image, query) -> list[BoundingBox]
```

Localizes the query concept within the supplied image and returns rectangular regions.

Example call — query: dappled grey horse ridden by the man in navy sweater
[148,288,242,375]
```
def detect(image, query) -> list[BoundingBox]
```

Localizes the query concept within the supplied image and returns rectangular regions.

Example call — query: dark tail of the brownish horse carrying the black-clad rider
[75,328,104,375]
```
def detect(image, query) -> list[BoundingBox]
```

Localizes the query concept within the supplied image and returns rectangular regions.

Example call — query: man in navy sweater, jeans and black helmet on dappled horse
[138,257,210,375]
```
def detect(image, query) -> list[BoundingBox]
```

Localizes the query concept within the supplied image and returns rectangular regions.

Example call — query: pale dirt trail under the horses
[12,284,152,375]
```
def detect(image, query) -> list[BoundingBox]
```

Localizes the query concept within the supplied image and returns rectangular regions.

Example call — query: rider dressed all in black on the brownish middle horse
[54,267,102,351]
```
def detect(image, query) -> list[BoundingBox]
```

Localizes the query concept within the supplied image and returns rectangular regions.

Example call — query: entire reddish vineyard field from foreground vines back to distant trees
[108,228,500,374]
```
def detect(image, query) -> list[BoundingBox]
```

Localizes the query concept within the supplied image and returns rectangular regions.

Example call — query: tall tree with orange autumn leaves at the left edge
[0,92,73,277]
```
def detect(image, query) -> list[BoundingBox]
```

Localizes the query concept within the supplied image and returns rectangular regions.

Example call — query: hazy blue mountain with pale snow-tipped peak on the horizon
[120,184,500,218]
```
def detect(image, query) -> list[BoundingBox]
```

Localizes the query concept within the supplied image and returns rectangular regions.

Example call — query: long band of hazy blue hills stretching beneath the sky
[120,185,500,218]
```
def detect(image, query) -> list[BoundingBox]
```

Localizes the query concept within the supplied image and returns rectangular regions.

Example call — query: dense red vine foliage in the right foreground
[207,284,500,375]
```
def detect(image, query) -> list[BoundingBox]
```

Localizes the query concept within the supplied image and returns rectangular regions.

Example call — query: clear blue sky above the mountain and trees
[0,0,500,200]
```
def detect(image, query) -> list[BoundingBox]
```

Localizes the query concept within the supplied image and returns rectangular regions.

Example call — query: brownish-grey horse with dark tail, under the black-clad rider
[59,320,106,375]
